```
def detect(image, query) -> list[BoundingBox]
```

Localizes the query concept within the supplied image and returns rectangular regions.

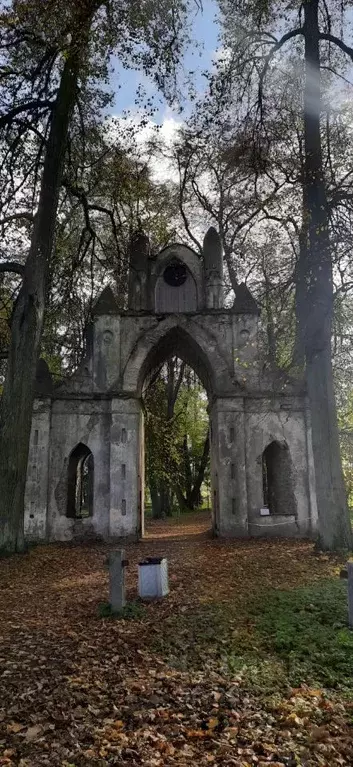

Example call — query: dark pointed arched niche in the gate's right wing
[262,441,296,515]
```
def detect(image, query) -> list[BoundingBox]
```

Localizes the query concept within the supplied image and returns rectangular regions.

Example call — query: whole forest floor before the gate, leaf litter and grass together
[0,514,353,767]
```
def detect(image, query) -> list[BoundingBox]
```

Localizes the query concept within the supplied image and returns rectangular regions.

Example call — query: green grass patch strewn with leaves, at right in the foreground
[155,578,353,694]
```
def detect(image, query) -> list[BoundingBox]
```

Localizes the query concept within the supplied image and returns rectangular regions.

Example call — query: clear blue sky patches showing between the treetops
[111,0,219,124]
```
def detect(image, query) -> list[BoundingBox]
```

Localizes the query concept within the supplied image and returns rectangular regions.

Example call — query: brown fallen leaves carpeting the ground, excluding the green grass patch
[0,515,353,767]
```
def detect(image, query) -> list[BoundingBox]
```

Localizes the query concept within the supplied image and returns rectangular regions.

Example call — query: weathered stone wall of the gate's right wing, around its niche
[211,396,317,537]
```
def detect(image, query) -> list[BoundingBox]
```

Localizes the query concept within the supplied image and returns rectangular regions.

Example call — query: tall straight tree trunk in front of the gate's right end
[302,0,352,551]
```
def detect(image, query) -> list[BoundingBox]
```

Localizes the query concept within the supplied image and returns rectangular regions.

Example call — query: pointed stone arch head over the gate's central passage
[119,315,234,397]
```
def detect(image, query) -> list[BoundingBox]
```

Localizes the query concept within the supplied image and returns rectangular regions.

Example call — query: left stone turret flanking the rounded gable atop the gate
[129,230,150,312]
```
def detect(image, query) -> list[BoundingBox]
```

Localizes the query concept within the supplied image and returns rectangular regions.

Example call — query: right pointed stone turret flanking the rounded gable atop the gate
[203,226,223,309]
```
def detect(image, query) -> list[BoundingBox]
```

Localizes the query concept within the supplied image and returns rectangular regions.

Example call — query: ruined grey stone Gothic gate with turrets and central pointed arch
[25,228,317,542]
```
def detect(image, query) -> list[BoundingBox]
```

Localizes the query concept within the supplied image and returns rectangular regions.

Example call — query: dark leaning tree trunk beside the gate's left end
[0,9,92,553]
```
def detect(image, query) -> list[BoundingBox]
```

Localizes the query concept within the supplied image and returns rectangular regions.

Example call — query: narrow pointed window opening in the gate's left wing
[66,442,94,519]
